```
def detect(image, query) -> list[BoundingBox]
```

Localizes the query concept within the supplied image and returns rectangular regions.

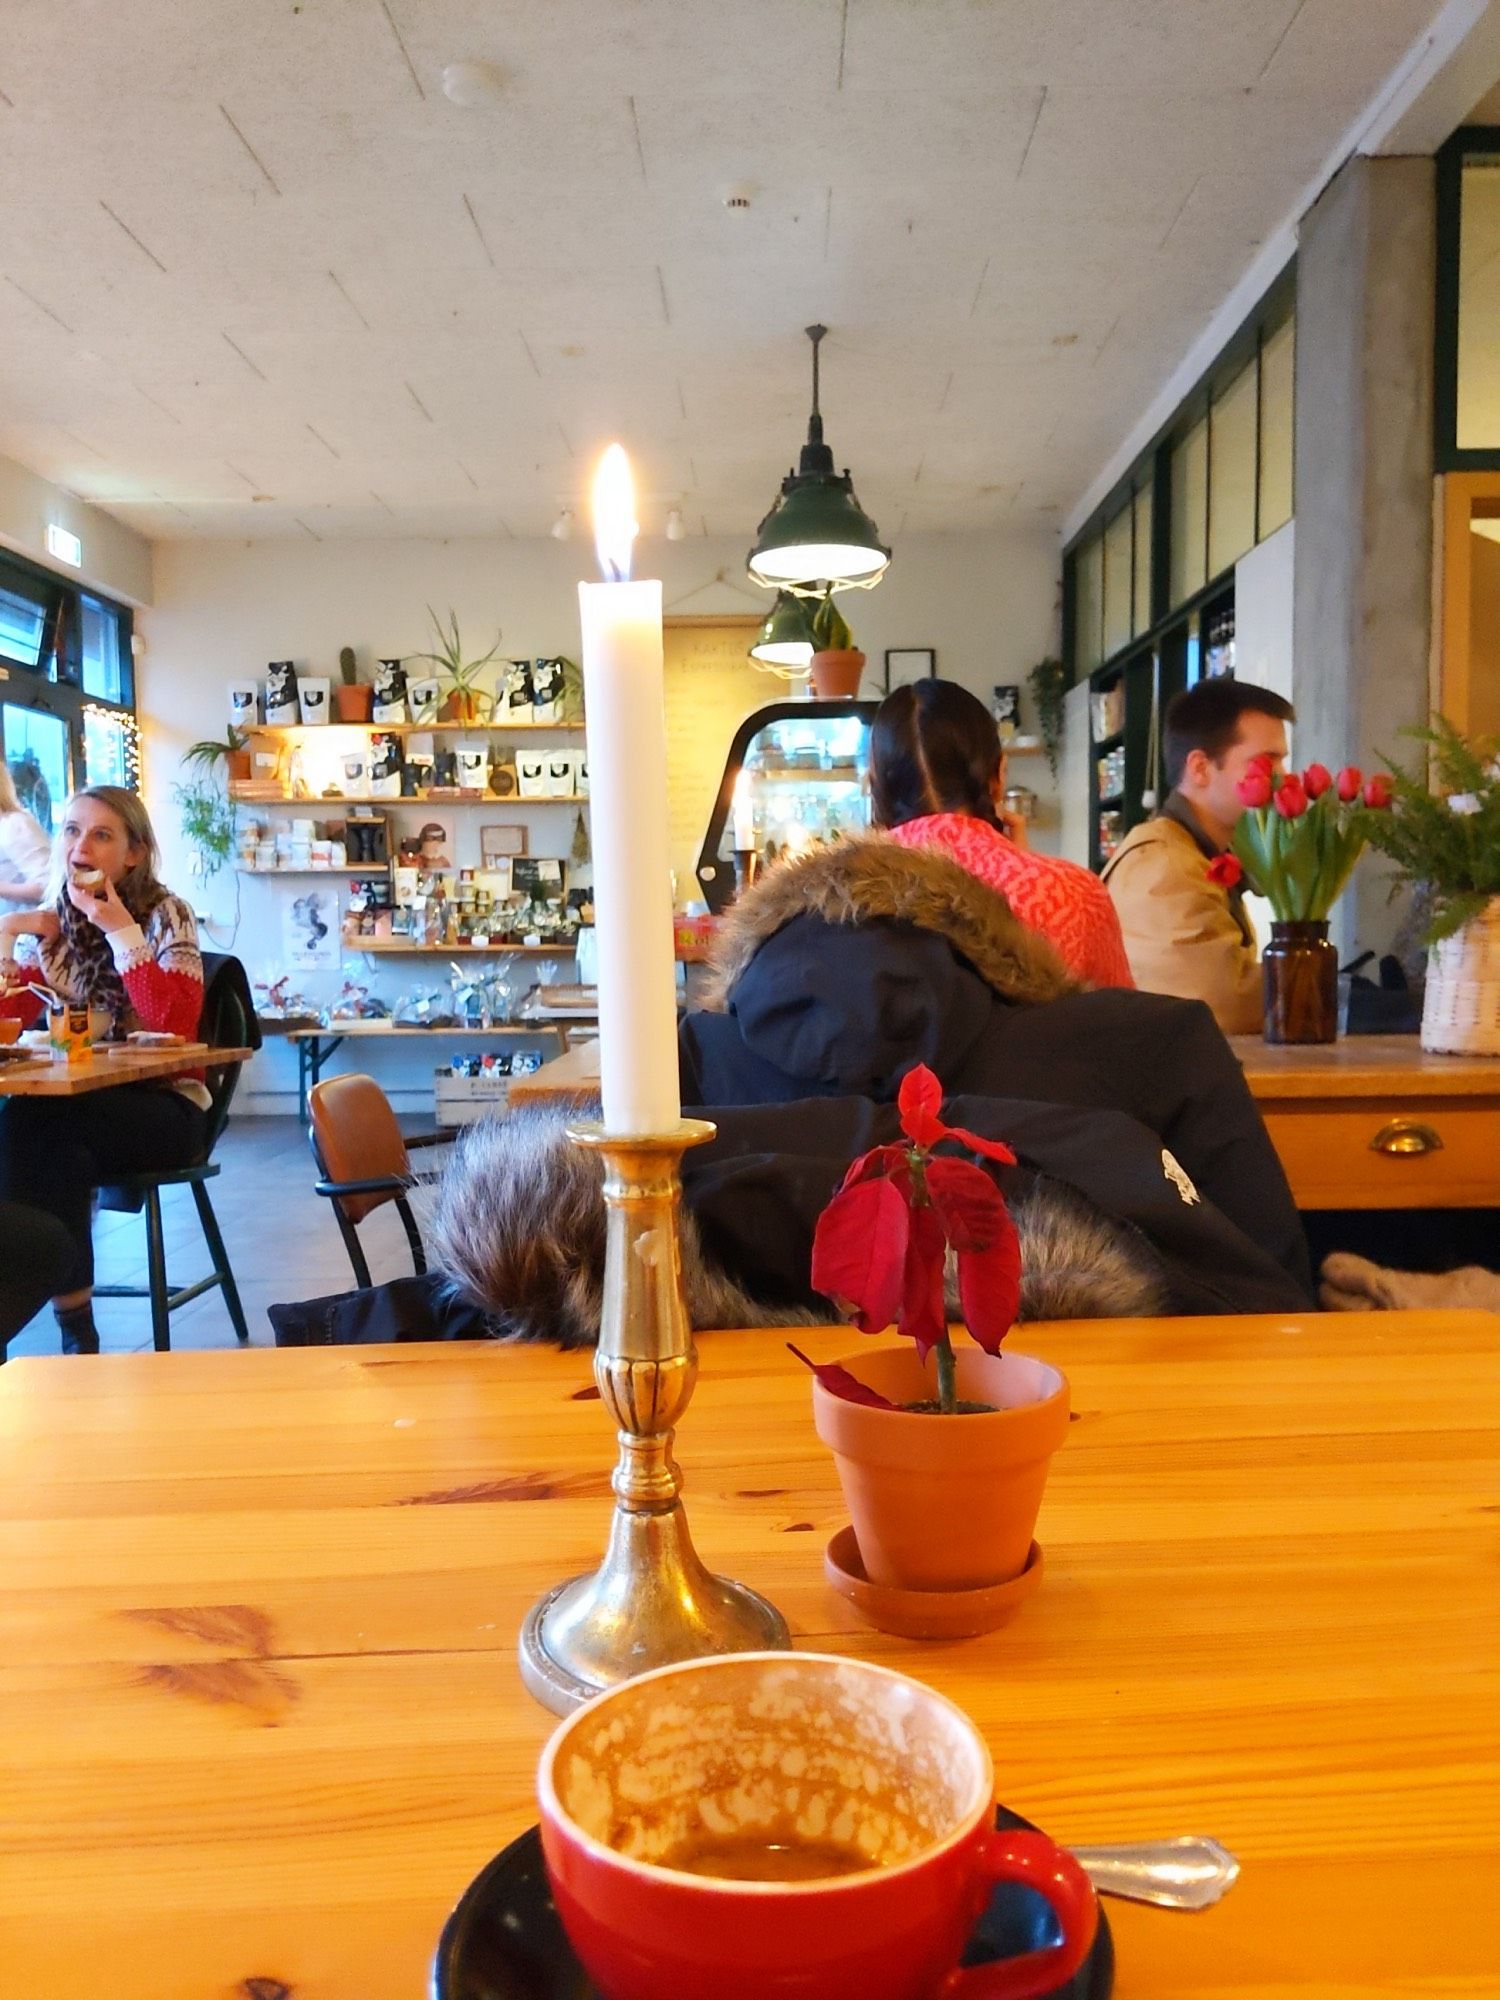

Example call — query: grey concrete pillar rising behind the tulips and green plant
[1292,158,1436,956]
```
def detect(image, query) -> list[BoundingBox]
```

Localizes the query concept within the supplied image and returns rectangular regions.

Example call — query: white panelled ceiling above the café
[0,0,1436,540]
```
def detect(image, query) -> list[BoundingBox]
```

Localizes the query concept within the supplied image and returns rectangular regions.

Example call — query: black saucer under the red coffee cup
[430,1806,1114,2000]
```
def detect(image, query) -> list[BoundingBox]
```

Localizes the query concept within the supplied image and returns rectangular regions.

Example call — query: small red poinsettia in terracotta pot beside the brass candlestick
[798,1066,1068,1634]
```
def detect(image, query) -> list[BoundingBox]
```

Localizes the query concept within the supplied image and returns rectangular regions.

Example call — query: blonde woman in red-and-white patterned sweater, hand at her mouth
[0,784,208,1354]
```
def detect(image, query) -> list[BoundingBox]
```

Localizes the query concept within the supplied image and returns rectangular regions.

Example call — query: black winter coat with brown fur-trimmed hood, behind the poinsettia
[680,836,1312,1312]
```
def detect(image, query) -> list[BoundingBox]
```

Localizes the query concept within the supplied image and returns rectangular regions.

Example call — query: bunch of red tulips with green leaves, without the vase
[1208,750,1392,924]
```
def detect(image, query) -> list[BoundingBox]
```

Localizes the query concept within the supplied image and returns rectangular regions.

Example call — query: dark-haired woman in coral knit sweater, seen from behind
[870,680,1136,986]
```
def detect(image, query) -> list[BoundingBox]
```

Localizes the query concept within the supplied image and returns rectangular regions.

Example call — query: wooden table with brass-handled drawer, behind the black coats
[510,1034,1500,1208]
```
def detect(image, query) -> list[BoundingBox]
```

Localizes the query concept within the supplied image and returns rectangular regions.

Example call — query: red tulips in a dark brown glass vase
[1208,752,1390,1042]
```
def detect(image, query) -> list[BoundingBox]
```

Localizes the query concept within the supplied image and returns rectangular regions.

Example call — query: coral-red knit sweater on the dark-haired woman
[890,812,1136,986]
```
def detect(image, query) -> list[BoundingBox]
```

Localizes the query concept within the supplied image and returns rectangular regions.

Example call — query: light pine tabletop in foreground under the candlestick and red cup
[0,1312,1500,2000]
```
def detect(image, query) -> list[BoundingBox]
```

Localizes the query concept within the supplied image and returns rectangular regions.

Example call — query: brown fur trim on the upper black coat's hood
[700,834,1078,1012]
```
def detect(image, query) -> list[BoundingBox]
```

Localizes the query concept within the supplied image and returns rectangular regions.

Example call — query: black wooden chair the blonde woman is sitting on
[94,952,260,1354]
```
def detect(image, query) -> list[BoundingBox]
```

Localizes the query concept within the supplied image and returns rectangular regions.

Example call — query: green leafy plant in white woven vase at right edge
[1368,716,1500,1056]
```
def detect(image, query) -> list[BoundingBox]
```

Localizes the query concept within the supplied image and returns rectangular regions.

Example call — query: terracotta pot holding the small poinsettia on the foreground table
[812,1344,1068,1590]
